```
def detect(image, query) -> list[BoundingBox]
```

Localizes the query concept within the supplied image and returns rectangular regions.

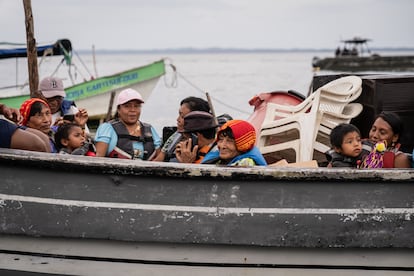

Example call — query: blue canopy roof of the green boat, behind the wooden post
[0,39,72,59]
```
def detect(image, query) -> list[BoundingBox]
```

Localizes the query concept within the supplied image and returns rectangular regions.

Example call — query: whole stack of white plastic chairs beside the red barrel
[258,76,362,162]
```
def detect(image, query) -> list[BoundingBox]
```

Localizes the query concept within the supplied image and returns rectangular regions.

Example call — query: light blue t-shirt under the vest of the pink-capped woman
[95,123,161,159]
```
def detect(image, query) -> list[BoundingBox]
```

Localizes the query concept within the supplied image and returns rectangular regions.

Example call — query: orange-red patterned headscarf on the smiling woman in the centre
[217,120,256,152]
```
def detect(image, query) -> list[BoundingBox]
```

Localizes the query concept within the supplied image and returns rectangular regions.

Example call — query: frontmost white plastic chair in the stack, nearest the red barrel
[258,91,321,162]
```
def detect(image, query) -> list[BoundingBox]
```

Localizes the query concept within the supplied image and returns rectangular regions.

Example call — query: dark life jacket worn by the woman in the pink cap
[109,120,155,160]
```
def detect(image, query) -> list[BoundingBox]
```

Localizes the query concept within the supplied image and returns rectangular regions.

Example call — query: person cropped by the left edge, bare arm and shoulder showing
[0,104,51,152]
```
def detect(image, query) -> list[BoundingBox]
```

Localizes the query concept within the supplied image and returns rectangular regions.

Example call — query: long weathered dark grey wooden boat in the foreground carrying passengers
[0,149,414,275]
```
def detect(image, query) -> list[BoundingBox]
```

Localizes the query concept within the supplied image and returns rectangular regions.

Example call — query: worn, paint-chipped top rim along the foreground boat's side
[0,149,414,182]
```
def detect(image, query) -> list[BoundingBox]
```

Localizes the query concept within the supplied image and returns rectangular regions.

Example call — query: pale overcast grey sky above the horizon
[0,0,414,50]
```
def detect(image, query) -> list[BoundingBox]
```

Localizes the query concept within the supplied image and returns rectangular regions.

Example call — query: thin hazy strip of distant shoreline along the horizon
[77,47,414,54]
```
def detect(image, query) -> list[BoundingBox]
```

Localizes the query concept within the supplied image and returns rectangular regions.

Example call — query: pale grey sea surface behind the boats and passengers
[0,51,414,135]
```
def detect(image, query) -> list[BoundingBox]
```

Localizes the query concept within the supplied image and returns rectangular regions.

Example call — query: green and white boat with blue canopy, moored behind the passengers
[0,39,166,120]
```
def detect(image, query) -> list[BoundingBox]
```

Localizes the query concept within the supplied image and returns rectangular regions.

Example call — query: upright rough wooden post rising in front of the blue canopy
[23,0,41,98]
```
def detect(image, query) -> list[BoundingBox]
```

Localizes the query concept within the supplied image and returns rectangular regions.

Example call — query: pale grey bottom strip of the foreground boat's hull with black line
[0,235,414,276]
